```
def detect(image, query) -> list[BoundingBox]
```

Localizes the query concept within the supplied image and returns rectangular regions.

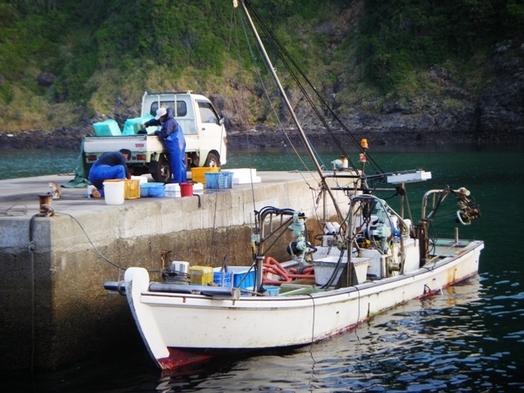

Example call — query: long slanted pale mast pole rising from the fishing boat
[233,0,344,221]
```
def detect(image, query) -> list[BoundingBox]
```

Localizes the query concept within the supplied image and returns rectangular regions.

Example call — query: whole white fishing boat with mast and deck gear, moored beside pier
[105,0,484,370]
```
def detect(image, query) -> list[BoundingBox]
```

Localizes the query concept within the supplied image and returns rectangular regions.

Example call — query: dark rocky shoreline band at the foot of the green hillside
[0,41,524,149]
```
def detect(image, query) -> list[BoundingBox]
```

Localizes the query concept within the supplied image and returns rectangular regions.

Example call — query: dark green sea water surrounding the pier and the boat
[0,148,524,393]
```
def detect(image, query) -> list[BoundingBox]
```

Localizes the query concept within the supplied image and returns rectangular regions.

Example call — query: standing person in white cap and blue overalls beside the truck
[142,108,187,183]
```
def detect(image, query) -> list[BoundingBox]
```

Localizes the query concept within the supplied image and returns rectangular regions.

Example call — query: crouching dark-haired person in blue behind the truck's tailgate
[88,149,131,198]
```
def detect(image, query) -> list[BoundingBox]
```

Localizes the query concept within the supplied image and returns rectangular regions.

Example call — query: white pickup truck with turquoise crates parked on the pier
[82,91,227,182]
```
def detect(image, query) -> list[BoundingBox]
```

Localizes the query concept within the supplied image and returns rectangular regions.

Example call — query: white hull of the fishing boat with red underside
[125,237,484,370]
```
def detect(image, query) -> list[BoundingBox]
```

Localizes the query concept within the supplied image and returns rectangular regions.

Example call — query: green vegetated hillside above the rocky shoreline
[0,0,524,132]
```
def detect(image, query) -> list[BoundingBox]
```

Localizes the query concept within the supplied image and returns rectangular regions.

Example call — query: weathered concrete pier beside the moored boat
[0,172,342,370]
